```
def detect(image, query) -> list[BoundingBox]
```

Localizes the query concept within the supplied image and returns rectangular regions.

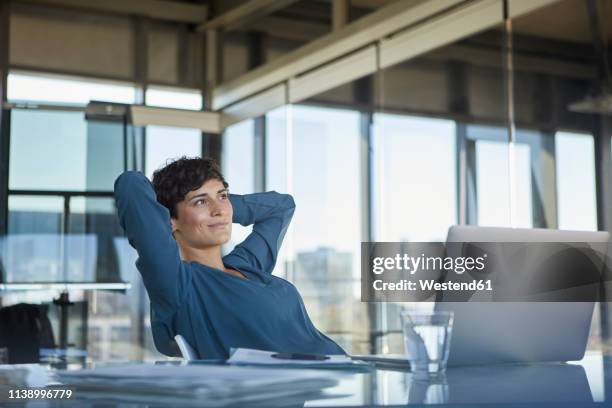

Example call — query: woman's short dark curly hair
[153,156,228,218]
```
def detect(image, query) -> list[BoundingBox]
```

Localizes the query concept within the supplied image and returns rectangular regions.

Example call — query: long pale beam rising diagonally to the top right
[212,0,559,111]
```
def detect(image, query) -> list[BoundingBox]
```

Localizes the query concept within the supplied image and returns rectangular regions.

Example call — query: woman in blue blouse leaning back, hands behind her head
[115,157,345,358]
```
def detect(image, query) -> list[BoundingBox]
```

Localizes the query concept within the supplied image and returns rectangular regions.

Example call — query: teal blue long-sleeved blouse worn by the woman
[115,171,345,359]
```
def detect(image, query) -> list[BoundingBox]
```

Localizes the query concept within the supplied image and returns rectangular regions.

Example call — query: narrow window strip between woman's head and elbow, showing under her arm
[221,120,255,252]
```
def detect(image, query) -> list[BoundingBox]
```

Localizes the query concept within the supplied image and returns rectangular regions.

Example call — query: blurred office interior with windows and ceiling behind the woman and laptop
[0,0,612,360]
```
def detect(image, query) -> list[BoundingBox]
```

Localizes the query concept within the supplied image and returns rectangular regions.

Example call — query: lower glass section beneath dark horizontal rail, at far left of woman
[0,195,125,282]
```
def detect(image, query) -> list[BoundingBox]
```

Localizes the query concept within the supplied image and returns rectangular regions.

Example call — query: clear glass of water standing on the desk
[401,310,453,374]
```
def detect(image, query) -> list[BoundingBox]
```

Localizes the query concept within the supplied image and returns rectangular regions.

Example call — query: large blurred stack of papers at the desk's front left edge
[57,364,338,407]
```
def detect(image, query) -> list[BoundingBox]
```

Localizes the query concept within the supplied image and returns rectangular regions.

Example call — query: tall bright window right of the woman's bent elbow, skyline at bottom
[266,105,368,352]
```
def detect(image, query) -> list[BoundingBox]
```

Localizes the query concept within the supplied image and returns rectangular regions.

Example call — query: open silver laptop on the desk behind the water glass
[435,226,609,366]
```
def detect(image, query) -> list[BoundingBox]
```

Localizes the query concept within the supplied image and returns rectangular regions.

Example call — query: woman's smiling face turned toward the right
[171,179,233,249]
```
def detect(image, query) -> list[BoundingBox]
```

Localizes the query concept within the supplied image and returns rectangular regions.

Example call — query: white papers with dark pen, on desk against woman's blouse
[227,348,370,369]
